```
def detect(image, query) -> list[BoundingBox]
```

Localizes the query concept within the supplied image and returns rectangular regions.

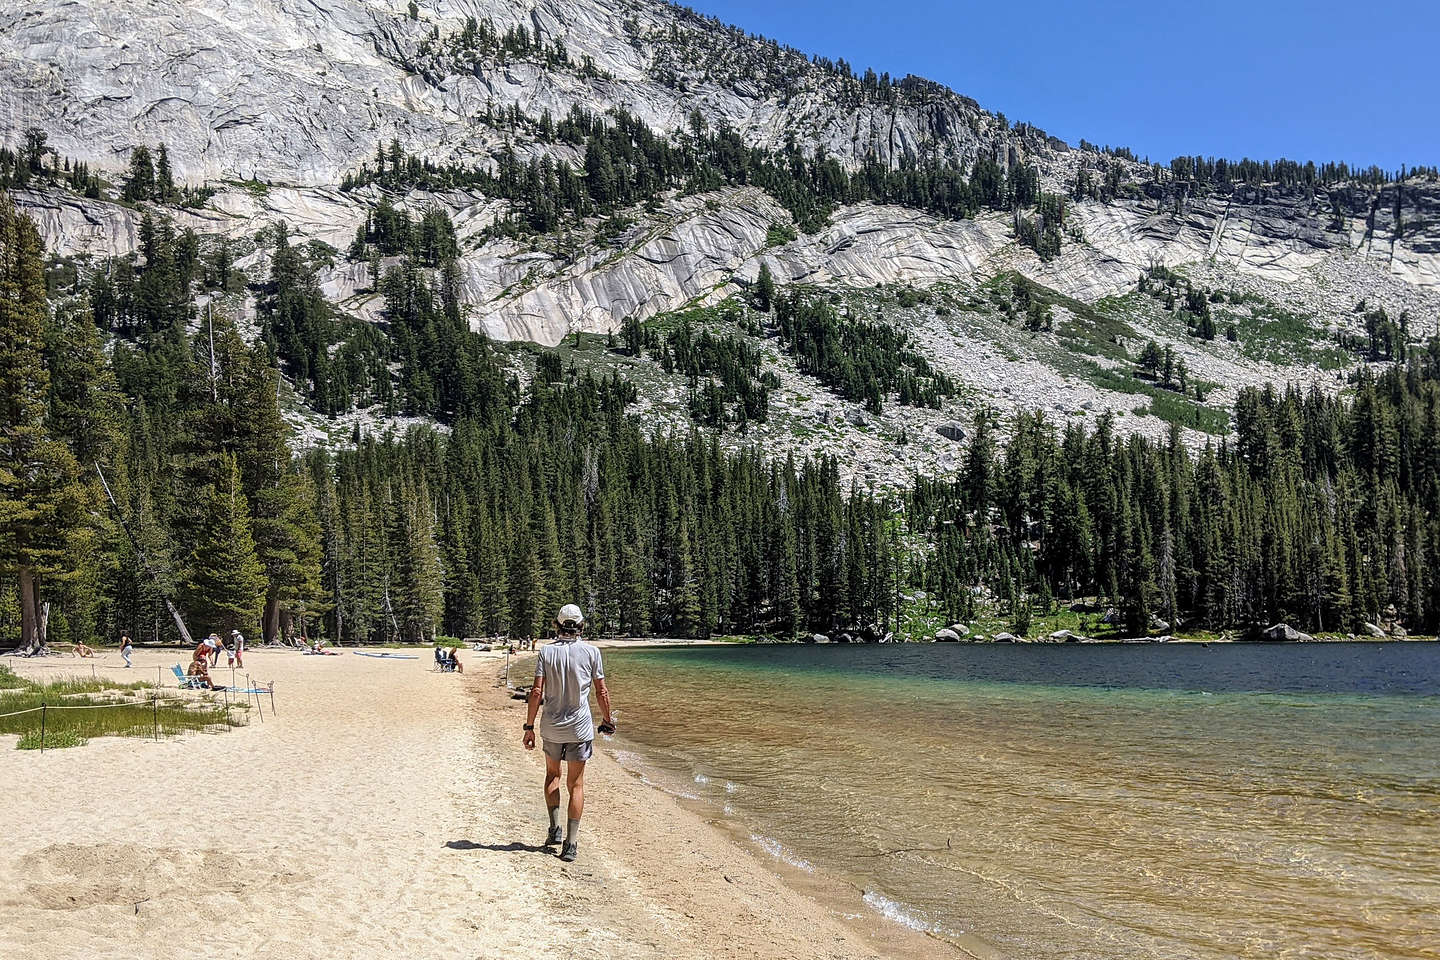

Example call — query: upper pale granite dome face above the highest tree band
[0,0,1013,186]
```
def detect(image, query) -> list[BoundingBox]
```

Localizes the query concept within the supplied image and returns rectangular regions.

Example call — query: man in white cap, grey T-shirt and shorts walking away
[523,603,615,864]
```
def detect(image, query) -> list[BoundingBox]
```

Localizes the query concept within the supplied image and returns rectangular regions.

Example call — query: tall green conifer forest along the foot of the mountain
[0,189,1440,648]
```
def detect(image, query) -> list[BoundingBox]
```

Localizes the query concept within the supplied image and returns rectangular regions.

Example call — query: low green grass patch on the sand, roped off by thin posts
[0,666,248,750]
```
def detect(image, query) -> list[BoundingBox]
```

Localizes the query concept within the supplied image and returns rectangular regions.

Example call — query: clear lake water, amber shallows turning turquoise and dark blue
[606,643,1440,959]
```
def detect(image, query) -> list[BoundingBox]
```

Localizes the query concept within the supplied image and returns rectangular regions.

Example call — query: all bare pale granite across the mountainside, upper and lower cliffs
[0,0,1440,466]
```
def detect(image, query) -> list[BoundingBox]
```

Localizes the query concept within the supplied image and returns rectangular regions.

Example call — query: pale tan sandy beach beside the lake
[0,649,959,960]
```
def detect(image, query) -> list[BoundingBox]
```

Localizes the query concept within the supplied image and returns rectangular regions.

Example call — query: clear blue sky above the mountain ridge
[690,0,1440,170]
